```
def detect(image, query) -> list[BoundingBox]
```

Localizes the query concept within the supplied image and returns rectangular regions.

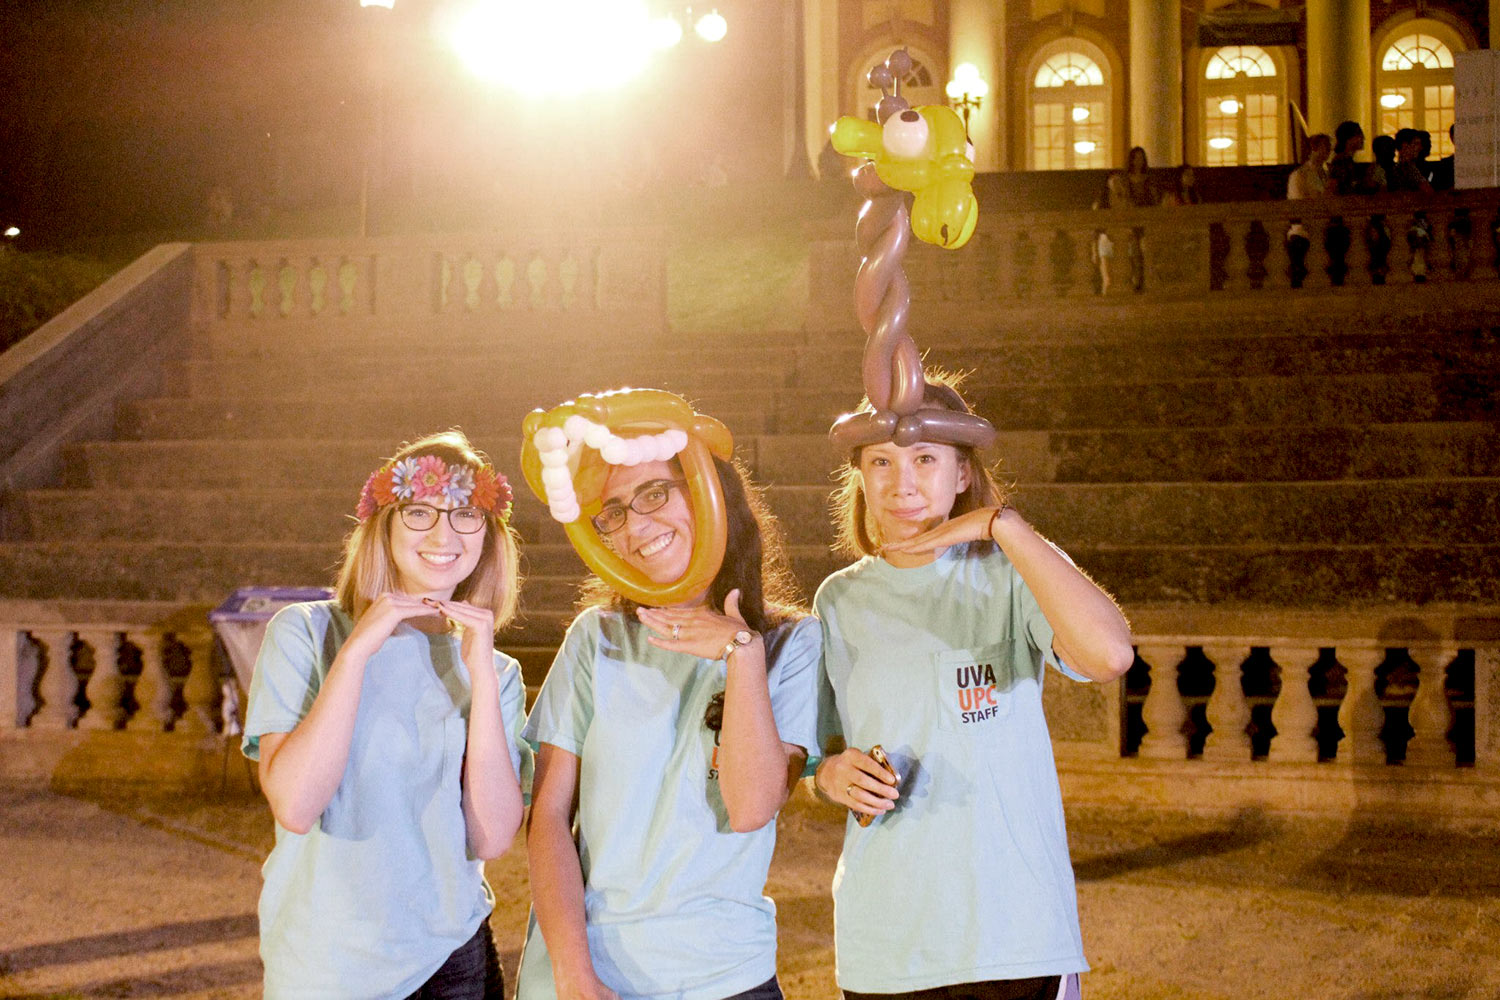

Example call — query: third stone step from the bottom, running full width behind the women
[65,421,1500,499]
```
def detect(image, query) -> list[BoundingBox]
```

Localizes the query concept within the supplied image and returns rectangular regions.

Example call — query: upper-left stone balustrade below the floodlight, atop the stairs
[194,229,666,333]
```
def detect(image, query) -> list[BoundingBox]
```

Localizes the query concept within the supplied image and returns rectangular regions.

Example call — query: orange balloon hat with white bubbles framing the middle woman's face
[521,388,734,607]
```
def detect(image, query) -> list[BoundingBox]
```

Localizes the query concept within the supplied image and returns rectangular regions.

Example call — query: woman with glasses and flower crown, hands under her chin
[243,432,530,1000]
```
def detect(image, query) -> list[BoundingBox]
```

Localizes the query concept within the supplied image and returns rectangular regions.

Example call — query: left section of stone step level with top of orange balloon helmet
[116,393,774,441]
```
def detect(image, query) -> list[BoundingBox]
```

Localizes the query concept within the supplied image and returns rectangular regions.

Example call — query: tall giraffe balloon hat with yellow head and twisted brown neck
[828,49,995,448]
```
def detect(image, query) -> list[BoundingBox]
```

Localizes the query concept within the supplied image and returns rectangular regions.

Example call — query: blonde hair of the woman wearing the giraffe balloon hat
[830,369,1010,559]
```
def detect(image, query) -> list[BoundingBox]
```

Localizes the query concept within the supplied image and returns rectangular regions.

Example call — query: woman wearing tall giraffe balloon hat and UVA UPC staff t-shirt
[813,52,1134,1000]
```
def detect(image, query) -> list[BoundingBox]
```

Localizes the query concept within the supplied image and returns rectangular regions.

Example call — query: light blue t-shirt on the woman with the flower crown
[243,601,530,1000]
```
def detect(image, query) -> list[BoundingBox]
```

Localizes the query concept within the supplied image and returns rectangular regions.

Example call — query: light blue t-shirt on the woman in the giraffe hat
[813,544,1088,993]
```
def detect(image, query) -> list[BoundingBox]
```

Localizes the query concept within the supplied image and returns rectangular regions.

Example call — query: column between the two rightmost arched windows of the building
[1307,0,1374,135]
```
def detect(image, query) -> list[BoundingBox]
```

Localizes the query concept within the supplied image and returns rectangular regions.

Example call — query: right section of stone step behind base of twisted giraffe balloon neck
[789,328,1500,391]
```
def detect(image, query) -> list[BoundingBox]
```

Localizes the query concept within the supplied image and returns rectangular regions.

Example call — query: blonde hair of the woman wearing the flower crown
[335,429,521,633]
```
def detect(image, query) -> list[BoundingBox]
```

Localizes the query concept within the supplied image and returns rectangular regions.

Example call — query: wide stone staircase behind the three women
[0,307,1500,695]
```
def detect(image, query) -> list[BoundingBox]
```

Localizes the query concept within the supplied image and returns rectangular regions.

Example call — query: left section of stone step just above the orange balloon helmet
[164,351,789,395]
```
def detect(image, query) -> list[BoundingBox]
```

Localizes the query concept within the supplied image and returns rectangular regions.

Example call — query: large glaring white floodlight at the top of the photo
[449,0,653,96]
